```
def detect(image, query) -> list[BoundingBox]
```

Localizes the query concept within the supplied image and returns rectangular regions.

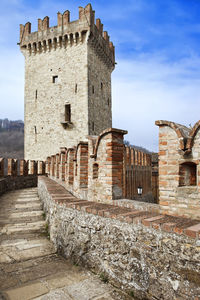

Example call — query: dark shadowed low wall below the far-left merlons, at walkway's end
[0,175,37,195]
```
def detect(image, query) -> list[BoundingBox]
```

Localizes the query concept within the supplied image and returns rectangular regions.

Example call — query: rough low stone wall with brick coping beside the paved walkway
[38,178,200,300]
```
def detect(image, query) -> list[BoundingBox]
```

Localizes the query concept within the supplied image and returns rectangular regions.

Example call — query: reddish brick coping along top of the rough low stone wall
[39,177,200,240]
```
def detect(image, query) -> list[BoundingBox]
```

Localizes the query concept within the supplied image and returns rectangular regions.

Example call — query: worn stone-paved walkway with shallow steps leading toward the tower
[0,188,129,300]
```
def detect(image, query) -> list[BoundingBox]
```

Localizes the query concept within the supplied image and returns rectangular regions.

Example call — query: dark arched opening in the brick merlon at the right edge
[179,162,197,186]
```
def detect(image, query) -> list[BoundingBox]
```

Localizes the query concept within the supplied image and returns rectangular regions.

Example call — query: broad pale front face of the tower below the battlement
[25,42,88,160]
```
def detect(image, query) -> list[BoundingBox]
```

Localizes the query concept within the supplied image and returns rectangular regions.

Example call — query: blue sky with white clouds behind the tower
[0,0,200,151]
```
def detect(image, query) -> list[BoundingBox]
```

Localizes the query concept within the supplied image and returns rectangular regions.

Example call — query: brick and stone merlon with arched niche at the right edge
[156,121,200,219]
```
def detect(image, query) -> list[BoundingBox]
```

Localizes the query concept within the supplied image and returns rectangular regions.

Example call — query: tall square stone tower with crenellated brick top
[19,4,115,160]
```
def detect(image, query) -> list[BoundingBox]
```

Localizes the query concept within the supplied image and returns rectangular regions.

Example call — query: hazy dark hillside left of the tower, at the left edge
[0,119,24,159]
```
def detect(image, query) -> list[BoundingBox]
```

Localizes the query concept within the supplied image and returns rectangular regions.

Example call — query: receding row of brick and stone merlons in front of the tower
[46,128,126,202]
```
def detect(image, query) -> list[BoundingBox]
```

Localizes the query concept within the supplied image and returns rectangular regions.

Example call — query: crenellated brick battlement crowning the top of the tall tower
[19,4,115,67]
